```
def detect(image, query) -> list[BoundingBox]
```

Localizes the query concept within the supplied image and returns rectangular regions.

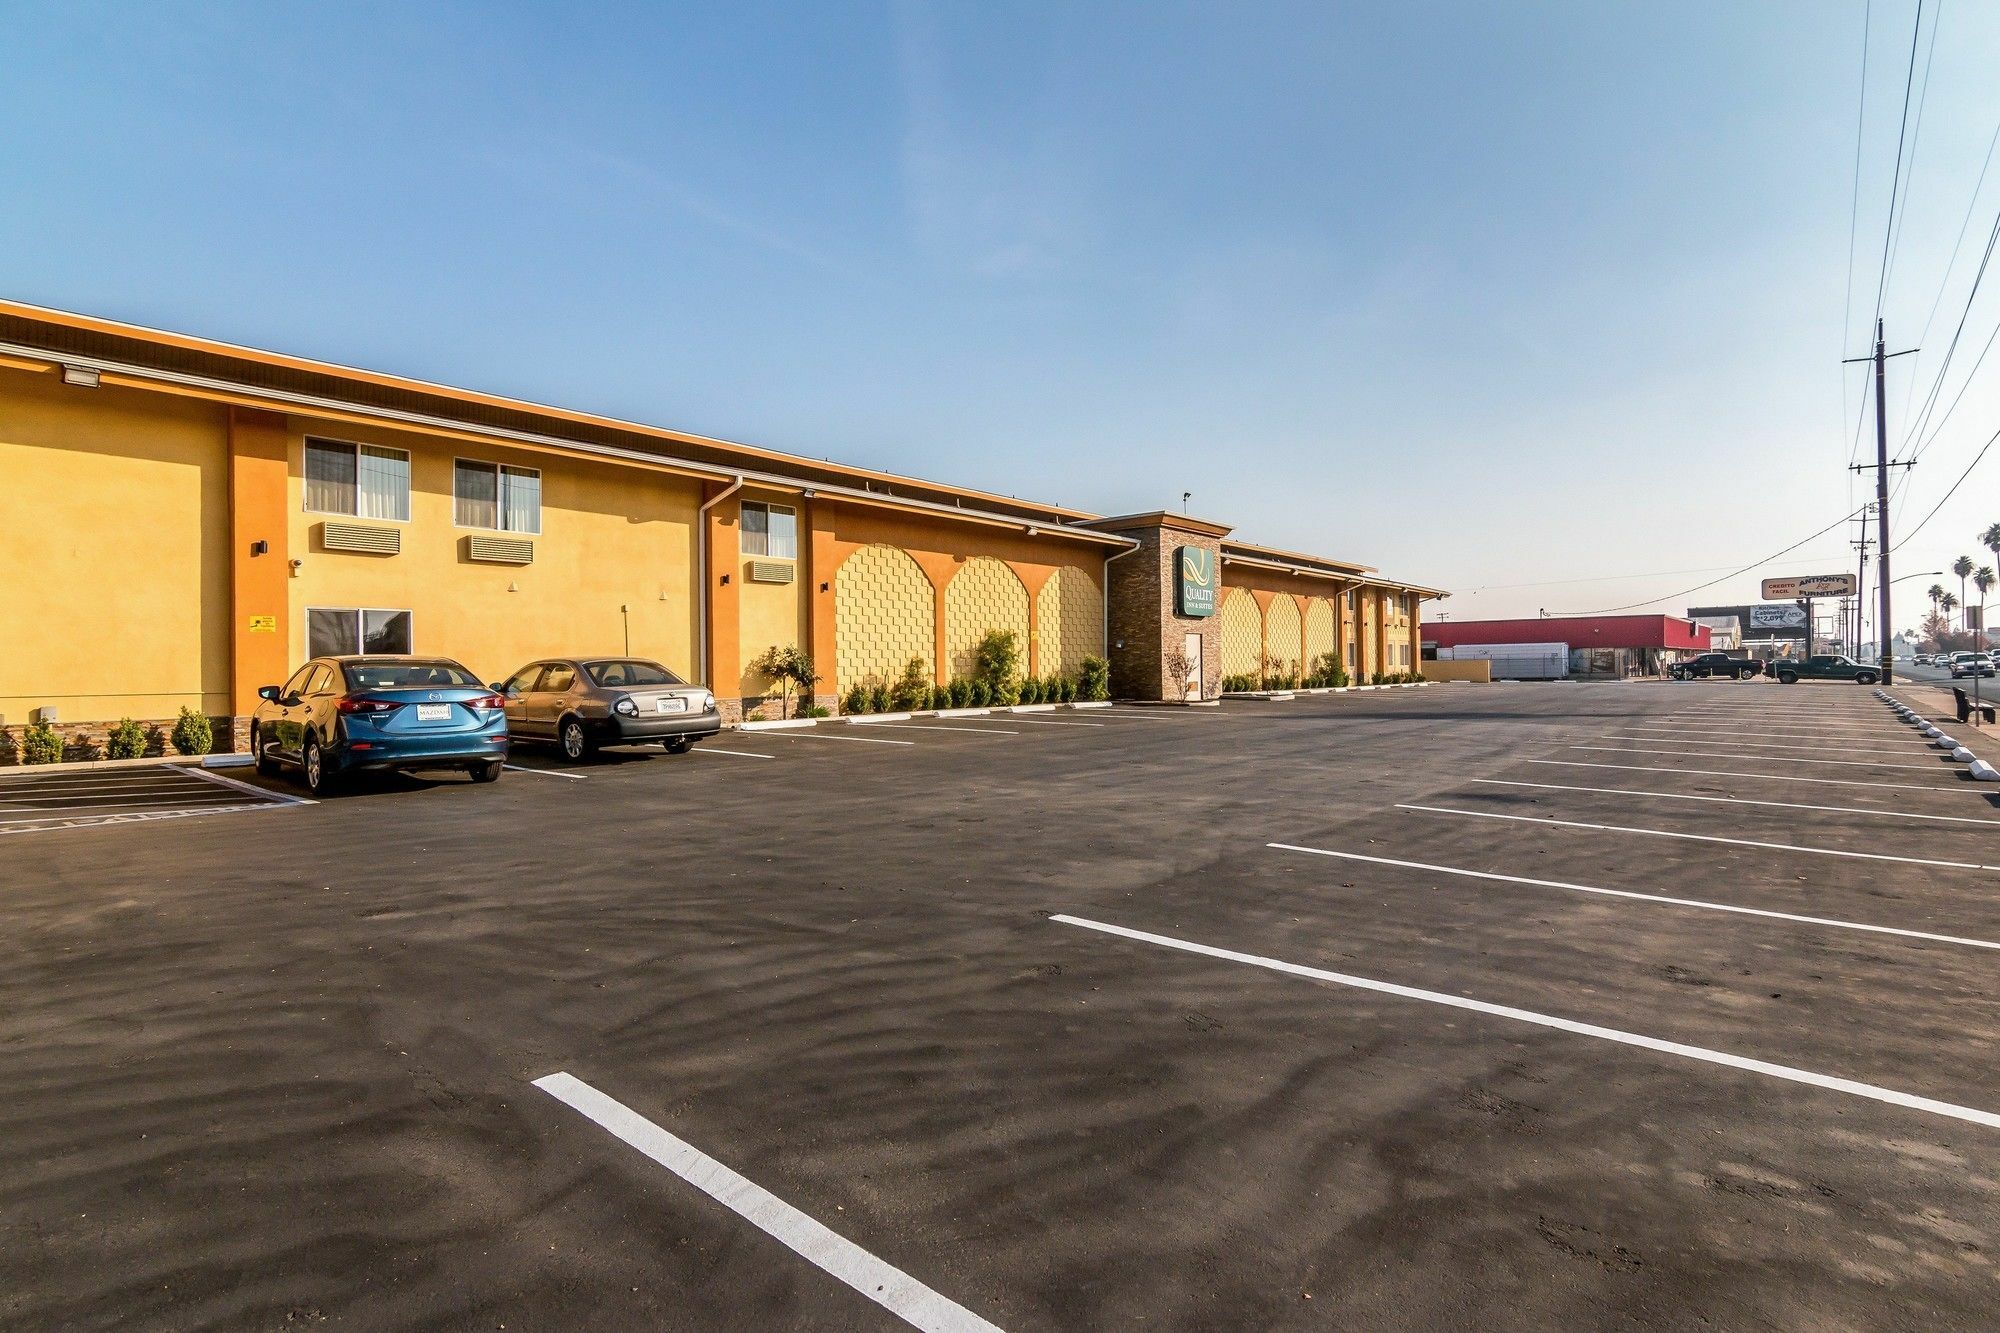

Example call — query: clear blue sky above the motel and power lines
[0,0,2000,620]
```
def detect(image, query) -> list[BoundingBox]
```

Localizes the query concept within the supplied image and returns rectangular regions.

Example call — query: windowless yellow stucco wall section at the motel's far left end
[0,370,230,727]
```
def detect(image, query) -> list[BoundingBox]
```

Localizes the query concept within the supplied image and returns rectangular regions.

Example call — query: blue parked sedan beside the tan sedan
[250,656,508,795]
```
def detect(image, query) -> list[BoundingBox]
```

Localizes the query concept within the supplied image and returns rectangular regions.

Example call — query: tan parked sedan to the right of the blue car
[492,656,722,761]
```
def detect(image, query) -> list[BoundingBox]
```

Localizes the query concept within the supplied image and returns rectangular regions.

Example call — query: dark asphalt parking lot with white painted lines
[0,681,2000,1329]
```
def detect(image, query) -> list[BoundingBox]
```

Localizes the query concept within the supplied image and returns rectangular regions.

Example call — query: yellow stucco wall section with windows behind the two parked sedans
[286,418,700,681]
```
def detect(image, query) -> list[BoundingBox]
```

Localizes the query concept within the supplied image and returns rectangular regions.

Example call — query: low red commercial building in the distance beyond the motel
[1424,616,1712,679]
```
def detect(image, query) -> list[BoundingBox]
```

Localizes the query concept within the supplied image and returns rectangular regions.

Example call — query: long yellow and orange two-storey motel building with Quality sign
[0,302,1442,763]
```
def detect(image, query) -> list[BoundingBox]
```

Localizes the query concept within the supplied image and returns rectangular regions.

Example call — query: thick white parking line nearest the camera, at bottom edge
[534,1073,1000,1333]
